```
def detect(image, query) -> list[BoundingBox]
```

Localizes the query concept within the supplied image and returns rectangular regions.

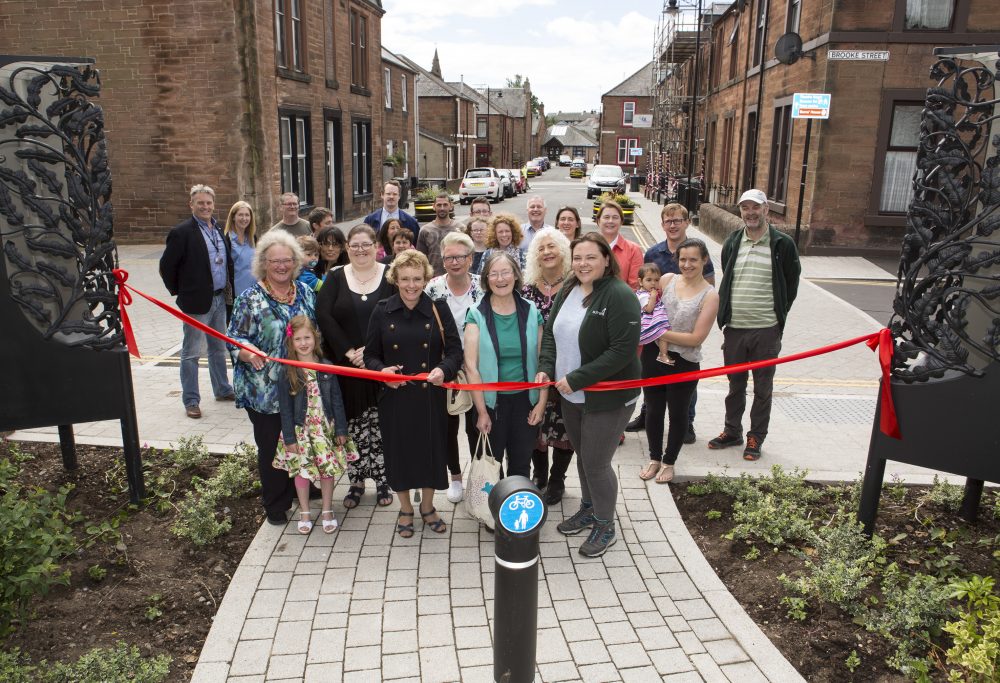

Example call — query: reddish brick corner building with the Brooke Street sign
[654,0,1000,253]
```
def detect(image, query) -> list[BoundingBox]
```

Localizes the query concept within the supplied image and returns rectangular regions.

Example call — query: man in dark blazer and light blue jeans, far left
[160,185,236,419]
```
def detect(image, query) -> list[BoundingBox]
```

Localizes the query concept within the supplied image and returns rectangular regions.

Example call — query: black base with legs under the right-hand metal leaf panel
[858,362,1000,535]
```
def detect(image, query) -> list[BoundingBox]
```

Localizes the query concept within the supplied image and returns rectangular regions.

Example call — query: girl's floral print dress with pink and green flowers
[272,370,358,483]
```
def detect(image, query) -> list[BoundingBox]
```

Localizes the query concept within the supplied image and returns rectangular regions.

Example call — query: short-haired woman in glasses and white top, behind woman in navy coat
[424,232,483,503]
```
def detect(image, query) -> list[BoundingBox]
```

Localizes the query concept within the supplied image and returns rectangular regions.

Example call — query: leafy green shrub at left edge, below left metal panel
[0,454,76,636]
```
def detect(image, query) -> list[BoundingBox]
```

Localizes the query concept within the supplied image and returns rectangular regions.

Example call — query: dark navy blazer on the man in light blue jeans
[160,216,233,315]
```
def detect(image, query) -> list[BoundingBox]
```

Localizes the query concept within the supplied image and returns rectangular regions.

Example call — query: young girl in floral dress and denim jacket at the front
[273,315,358,534]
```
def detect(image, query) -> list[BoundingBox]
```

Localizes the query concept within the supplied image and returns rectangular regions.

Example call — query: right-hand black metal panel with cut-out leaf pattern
[890,52,1000,382]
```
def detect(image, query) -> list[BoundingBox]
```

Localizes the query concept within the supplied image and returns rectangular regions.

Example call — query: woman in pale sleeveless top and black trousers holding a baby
[639,239,719,484]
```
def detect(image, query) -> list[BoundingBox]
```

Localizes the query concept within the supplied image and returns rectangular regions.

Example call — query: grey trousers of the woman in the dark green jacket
[561,398,635,521]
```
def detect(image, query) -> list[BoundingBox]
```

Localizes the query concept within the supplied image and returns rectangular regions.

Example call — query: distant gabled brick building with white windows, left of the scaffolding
[598,62,653,175]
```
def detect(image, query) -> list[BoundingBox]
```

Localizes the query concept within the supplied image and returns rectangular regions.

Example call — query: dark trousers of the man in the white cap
[722,325,781,442]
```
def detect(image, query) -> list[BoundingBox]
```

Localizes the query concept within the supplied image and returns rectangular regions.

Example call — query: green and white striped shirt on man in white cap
[729,229,778,330]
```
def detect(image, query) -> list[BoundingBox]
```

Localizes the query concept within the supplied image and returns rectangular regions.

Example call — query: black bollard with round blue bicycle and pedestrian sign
[490,476,546,683]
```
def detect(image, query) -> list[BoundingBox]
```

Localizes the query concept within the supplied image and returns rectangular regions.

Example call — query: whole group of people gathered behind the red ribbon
[160,182,798,556]
